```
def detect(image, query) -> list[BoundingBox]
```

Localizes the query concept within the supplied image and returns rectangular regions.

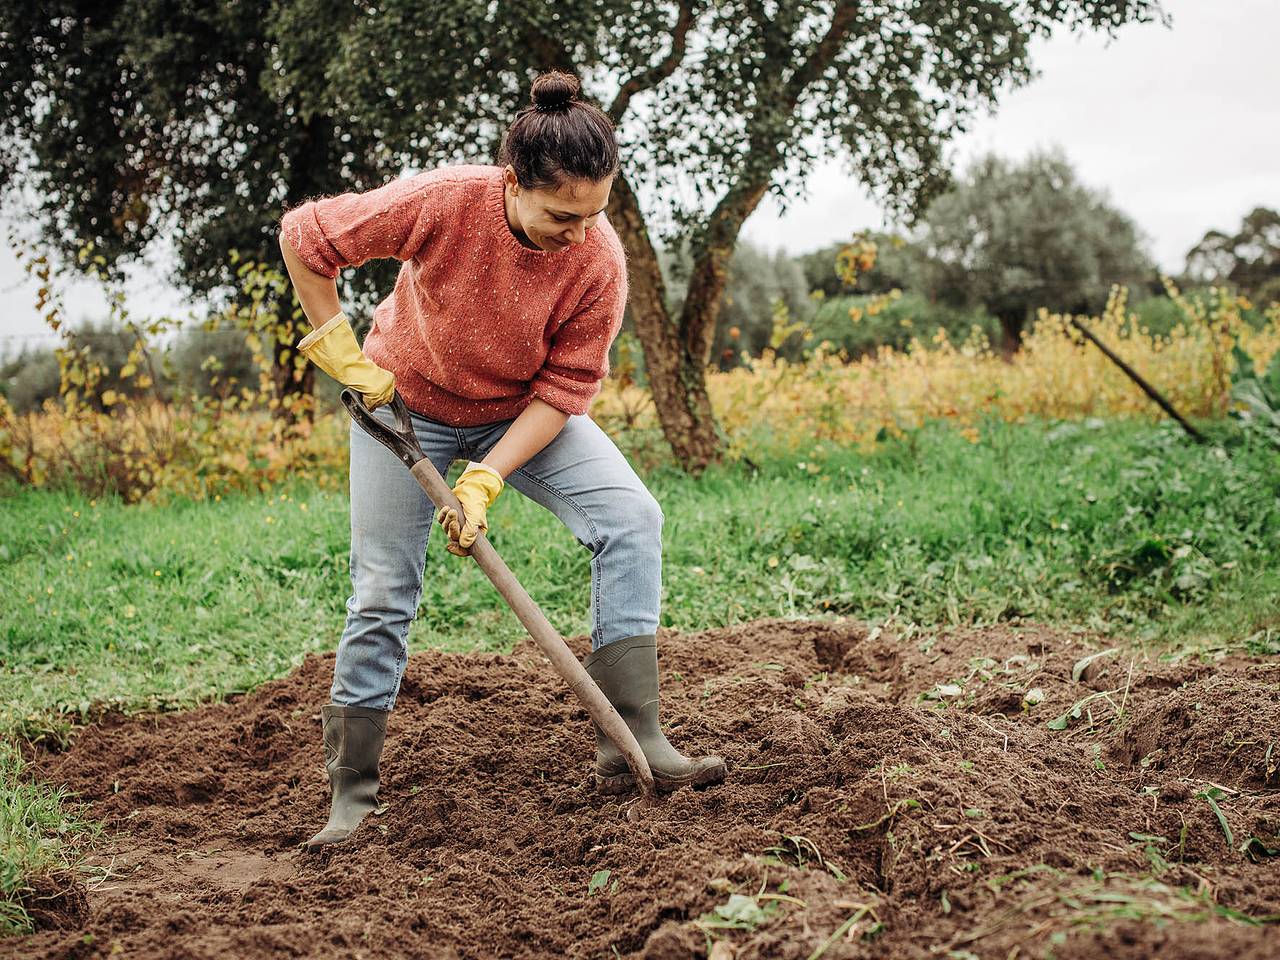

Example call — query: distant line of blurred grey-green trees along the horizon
[0,150,1280,411]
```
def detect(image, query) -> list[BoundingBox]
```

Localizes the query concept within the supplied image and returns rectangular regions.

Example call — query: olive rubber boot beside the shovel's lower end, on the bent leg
[582,634,724,794]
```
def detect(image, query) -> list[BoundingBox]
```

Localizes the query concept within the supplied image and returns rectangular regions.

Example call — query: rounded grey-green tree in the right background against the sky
[916,150,1155,349]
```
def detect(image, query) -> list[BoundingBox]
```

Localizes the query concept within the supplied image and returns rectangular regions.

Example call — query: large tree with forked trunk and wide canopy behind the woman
[3,0,1162,470]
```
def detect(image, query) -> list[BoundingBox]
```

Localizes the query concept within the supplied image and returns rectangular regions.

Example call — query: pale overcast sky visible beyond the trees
[0,0,1280,356]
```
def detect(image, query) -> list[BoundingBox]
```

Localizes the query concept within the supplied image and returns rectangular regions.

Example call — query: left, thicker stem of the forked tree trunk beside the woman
[609,174,724,474]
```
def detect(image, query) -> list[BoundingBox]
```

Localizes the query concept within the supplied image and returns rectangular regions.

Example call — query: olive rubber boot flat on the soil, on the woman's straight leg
[303,704,389,850]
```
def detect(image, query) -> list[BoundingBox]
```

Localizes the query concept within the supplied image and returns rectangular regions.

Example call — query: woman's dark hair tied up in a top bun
[498,70,618,189]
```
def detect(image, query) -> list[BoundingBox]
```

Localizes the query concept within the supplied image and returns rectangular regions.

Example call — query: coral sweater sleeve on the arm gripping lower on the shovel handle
[531,265,627,416]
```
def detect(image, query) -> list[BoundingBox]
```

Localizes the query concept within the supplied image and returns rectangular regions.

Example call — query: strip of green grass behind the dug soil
[0,421,1280,936]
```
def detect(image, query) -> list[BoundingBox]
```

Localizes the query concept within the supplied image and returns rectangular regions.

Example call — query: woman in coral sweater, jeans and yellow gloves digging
[280,73,724,850]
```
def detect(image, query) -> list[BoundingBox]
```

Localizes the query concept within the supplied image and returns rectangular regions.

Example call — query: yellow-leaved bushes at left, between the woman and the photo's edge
[0,256,330,502]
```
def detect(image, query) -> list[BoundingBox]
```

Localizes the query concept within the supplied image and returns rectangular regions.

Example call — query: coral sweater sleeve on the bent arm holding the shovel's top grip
[280,174,429,278]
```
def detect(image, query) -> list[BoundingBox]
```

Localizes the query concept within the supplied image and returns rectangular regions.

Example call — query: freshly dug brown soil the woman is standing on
[10,621,1280,960]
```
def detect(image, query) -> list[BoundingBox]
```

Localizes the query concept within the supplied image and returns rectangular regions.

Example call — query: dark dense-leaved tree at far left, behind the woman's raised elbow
[0,0,401,419]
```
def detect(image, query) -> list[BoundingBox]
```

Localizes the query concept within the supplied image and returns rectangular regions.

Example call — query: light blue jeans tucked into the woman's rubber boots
[330,407,663,710]
